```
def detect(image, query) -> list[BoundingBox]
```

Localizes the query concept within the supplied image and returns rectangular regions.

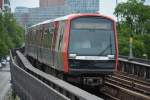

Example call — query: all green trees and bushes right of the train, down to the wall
[114,0,150,58]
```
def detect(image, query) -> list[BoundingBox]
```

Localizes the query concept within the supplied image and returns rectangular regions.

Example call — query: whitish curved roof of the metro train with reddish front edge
[29,13,114,28]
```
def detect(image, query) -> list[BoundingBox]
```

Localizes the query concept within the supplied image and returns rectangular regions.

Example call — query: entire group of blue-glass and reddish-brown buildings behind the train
[15,0,99,26]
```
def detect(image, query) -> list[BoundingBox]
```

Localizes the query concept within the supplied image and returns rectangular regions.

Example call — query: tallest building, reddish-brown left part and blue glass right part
[40,0,99,13]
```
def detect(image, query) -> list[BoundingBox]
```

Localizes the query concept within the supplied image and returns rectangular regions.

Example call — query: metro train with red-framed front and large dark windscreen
[25,14,118,85]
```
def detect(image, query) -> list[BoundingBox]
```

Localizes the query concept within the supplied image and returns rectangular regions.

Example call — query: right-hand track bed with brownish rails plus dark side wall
[101,57,150,100]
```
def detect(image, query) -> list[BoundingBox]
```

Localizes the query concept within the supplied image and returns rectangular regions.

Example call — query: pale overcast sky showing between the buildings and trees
[10,0,150,19]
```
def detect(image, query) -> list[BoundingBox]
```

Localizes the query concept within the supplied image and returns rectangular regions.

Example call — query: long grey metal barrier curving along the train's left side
[10,50,102,100]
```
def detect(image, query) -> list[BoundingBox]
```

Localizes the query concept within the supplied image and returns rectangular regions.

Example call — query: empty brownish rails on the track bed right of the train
[101,74,150,100]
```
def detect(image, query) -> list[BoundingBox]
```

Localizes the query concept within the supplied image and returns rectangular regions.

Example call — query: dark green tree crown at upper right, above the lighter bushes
[114,0,150,34]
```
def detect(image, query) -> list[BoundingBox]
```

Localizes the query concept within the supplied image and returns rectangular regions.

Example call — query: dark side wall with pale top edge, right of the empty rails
[119,58,150,81]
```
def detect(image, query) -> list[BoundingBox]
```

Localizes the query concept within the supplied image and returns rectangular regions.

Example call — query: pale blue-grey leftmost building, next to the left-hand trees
[14,7,29,27]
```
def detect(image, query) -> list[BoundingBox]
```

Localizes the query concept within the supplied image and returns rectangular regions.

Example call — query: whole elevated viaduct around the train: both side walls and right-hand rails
[10,49,150,100]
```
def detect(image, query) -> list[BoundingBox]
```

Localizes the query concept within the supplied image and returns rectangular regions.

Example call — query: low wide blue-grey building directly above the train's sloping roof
[28,6,68,26]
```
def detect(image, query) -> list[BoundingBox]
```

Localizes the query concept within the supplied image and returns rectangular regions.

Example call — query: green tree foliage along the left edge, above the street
[0,12,23,58]
